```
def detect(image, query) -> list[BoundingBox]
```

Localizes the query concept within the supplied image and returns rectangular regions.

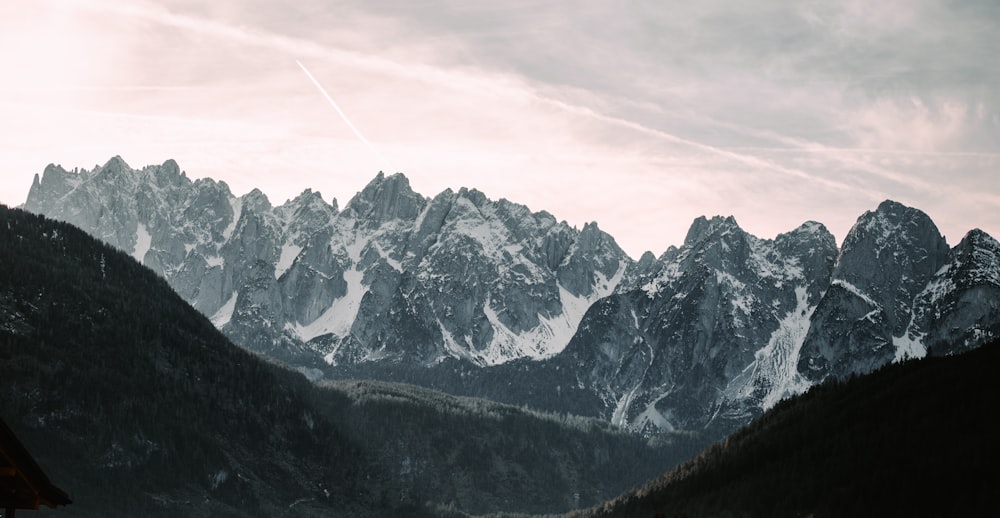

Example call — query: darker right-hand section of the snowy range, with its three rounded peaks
[563,201,1000,431]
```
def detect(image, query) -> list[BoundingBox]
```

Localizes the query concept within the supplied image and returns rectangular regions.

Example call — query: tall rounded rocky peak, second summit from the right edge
[800,201,949,380]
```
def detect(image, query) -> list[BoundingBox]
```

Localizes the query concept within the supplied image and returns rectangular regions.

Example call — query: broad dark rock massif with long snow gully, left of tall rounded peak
[565,217,836,431]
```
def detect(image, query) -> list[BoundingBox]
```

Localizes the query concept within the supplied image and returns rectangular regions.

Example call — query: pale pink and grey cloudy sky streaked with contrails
[0,0,1000,257]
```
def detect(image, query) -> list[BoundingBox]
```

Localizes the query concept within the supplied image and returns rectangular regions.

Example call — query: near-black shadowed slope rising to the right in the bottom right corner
[571,342,1000,517]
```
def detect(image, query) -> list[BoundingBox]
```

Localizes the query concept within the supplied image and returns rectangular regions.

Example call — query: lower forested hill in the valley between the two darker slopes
[322,381,707,514]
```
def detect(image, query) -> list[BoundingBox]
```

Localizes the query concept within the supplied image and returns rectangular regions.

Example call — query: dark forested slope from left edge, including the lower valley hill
[0,206,688,516]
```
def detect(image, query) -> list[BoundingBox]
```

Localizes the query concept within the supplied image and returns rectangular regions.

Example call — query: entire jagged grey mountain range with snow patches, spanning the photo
[25,157,1000,433]
